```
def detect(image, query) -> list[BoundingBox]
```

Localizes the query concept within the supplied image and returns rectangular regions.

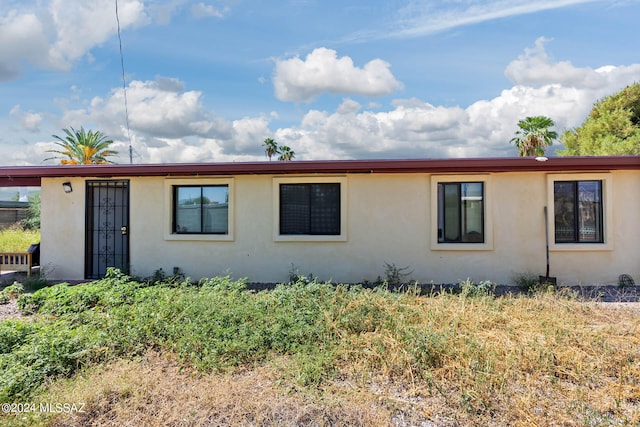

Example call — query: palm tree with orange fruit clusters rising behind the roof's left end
[46,127,118,165]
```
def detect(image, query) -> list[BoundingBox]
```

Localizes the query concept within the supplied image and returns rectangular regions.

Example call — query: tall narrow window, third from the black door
[438,182,485,243]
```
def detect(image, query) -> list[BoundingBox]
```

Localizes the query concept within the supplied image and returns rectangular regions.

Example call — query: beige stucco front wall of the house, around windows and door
[41,171,640,284]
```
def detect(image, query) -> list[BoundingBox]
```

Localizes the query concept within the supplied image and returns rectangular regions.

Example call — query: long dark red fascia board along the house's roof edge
[0,156,640,187]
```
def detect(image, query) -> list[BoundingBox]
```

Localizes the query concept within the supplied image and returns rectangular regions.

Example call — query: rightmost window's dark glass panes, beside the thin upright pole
[553,180,604,243]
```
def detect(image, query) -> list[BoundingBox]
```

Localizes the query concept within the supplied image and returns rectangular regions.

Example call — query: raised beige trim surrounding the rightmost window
[547,173,614,252]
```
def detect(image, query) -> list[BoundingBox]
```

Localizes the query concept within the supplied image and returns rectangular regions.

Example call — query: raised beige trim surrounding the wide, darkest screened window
[272,176,347,242]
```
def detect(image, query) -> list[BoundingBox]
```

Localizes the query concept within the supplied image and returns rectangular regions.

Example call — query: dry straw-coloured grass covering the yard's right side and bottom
[1,292,640,427]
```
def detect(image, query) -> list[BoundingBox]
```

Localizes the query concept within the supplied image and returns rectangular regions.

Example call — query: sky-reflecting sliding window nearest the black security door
[172,185,229,234]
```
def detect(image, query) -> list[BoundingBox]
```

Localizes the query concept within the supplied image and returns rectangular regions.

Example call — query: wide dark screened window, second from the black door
[279,182,341,236]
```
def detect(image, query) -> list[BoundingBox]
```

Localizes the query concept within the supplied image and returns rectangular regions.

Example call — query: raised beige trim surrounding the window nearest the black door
[164,178,235,241]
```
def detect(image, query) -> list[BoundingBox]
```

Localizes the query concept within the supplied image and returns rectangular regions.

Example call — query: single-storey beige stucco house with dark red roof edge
[0,156,640,284]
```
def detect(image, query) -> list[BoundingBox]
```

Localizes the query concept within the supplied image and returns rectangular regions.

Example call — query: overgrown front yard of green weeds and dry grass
[0,271,640,426]
